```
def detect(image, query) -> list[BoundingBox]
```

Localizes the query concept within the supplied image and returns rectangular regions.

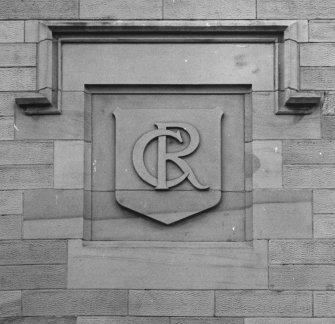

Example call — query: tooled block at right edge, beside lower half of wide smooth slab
[269,264,335,290]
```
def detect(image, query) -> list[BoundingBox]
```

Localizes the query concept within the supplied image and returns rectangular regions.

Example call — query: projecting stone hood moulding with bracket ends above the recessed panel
[16,20,323,115]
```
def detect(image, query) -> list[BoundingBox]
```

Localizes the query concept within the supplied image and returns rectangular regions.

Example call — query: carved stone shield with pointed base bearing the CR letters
[114,108,223,224]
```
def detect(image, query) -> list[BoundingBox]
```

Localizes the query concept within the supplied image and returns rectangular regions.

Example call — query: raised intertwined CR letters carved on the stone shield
[133,122,209,190]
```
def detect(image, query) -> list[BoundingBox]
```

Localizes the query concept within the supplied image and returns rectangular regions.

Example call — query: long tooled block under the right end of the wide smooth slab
[215,290,312,317]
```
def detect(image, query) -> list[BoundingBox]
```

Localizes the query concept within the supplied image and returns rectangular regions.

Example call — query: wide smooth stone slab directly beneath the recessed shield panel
[68,240,268,290]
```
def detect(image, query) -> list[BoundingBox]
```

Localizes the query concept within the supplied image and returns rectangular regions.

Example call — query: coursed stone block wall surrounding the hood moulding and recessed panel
[0,0,335,324]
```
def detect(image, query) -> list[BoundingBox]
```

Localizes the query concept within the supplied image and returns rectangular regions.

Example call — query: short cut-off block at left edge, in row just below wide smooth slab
[0,291,21,316]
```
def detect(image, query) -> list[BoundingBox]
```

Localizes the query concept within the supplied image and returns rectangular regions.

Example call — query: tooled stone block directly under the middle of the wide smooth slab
[129,290,214,316]
